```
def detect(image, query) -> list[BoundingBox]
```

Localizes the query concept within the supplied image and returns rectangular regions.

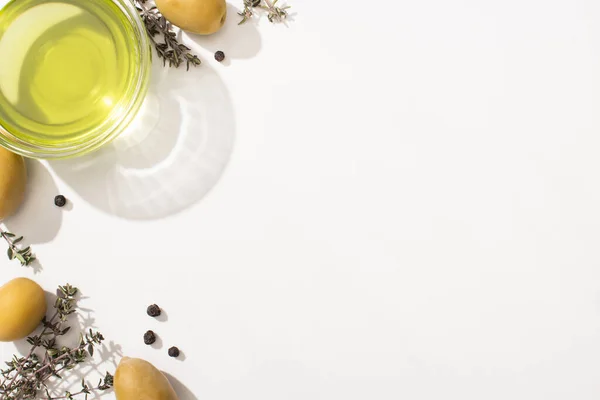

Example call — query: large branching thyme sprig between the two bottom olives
[0,284,113,400]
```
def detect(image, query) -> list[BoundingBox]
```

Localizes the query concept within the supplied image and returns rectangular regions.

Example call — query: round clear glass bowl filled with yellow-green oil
[0,0,152,159]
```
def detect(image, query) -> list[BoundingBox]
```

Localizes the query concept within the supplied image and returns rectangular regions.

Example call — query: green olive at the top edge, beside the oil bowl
[156,0,227,35]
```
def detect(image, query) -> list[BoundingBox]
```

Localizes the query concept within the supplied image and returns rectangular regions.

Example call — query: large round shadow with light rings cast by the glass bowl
[48,61,235,220]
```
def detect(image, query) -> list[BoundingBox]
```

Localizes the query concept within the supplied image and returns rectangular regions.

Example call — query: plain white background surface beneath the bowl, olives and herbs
[0,0,600,400]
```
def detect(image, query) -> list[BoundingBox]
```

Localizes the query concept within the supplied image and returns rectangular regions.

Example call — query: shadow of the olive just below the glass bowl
[3,160,63,250]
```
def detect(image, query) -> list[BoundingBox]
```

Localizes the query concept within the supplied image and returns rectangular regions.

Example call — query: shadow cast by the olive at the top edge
[186,4,262,61]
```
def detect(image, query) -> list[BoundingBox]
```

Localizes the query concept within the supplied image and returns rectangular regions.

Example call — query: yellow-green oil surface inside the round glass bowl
[0,0,136,145]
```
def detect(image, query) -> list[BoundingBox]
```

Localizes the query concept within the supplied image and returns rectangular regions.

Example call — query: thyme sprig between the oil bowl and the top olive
[135,0,202,71]
